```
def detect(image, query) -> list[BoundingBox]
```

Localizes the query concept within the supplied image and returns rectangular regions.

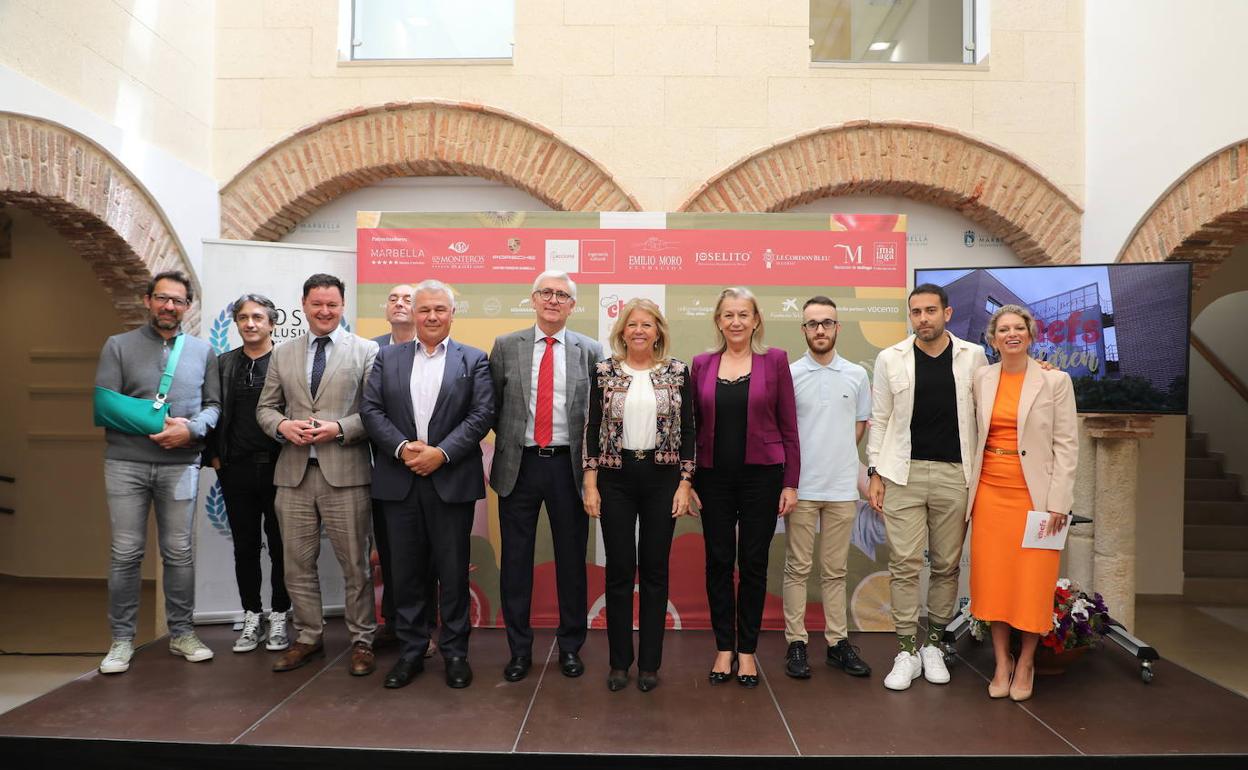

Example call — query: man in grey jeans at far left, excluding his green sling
[95,271,221,674]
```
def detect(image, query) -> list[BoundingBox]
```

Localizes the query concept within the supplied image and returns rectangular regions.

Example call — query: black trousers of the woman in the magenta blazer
[694,465,784,655]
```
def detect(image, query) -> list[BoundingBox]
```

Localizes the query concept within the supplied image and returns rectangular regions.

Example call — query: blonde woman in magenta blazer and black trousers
[693,288,801,688]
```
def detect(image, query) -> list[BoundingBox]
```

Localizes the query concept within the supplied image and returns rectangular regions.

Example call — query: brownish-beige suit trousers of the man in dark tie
[275,465,377,645]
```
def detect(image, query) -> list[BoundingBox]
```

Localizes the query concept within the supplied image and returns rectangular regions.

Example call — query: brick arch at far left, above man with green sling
[0,112,202,333]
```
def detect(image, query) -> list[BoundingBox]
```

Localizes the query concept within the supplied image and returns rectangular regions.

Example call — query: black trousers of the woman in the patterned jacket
[598,451,680,671]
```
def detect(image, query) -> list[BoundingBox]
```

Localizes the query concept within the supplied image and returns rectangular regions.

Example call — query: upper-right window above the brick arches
[810,0,975,64]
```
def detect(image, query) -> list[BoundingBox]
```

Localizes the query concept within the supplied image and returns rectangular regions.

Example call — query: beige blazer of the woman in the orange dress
[966,359,1080,520]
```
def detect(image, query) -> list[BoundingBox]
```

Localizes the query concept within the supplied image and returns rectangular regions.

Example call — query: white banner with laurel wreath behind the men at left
[195,240,357,623]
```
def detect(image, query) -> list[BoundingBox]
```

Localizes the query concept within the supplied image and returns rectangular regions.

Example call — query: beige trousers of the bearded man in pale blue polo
[784,500,857,646]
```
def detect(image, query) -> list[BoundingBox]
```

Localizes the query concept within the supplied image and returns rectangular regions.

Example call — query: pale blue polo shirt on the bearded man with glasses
[789,352,871,503]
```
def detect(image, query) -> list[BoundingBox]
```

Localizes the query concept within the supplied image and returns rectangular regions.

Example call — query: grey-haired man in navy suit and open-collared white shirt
[361,280,494,689]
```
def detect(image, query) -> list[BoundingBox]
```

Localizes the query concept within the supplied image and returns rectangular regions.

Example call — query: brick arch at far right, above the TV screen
[1117,140,1248,281]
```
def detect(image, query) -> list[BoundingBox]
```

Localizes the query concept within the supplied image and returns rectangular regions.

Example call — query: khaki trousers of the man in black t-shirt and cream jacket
[884,461,966,635]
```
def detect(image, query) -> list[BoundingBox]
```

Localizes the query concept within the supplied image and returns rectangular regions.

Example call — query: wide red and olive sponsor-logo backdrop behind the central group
[357,211,907,630]
